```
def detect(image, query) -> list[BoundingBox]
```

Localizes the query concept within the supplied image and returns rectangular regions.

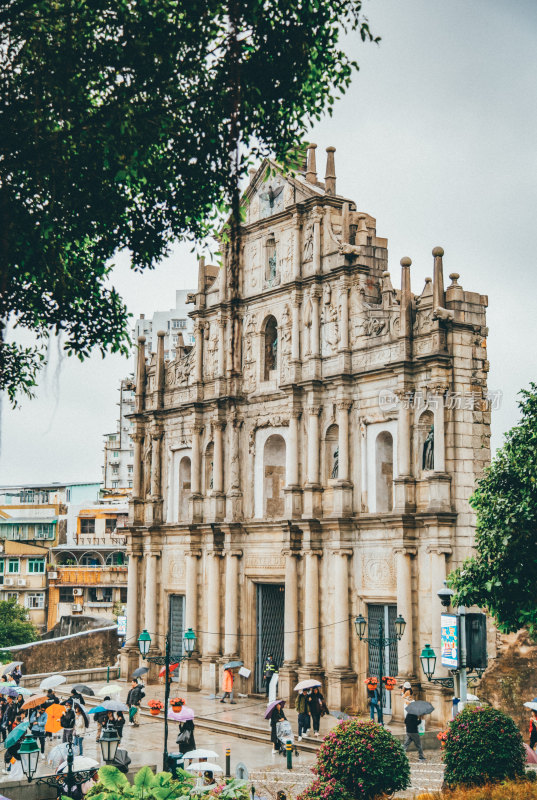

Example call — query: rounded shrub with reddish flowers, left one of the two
[305,719,410,800]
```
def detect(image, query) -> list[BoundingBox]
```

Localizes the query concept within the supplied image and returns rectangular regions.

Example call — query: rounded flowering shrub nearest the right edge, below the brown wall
[444,706,526,786]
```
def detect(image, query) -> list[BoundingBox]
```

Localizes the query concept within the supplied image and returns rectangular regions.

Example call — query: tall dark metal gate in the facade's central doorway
[255,583,285,692]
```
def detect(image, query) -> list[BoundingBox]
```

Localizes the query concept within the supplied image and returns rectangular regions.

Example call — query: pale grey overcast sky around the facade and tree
[0,0,537,483]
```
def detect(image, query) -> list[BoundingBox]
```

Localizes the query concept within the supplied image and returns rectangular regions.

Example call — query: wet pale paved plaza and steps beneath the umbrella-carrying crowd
[0,681,443,799]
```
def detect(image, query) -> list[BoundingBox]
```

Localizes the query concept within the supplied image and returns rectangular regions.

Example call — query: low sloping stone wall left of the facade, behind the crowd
[6,625,119,675]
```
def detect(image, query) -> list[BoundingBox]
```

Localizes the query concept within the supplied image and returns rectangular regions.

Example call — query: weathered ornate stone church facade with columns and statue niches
[124,146,490,724]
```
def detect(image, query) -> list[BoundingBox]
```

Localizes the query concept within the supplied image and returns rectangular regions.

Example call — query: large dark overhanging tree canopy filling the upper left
[0,0,372,401]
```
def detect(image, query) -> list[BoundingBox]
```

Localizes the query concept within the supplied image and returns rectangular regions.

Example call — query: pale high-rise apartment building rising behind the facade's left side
[103,289,194,489]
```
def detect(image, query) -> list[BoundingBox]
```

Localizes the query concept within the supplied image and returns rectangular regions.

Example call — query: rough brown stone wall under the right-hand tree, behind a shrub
[479,630,537,739]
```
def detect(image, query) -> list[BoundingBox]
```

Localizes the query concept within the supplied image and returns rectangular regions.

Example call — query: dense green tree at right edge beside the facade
[450,383,537,637]
